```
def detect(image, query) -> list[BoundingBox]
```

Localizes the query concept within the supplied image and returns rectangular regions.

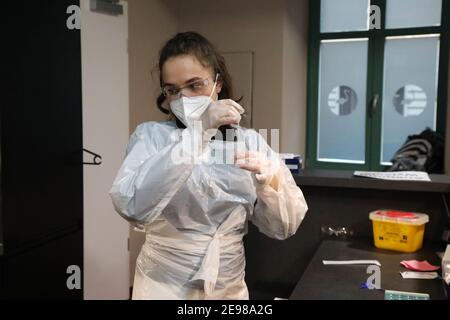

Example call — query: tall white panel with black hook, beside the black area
[81,0,129,299]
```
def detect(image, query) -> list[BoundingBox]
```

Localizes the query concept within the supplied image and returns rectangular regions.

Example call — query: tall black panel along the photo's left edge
[0,0,83,299]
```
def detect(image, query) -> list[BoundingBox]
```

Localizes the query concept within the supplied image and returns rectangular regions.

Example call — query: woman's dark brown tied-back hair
[156,31,242,128]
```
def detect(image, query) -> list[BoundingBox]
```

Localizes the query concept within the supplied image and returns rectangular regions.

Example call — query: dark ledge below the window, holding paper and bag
[294,169,450,193]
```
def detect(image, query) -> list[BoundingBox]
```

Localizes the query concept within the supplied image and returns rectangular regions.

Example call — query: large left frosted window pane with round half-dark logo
[317,39,368,163]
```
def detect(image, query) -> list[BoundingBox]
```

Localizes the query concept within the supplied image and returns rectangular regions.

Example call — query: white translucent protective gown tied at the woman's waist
[110,121,308,300]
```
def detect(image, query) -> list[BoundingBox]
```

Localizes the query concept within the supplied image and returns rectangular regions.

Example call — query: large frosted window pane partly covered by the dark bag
[381,35,439,164]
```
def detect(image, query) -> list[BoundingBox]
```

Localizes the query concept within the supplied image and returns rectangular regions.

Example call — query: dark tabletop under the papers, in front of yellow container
[289,239,445,300]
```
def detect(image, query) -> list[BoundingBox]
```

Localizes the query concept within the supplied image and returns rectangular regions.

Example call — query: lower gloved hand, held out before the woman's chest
[235,152,280,190]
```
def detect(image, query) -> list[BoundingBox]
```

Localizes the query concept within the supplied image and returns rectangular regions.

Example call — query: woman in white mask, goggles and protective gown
[110,32,307,299]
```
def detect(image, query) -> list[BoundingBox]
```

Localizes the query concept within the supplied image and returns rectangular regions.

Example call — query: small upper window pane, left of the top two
[320,0,370,32]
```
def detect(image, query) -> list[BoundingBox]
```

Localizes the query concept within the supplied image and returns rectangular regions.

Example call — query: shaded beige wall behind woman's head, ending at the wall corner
[178,0,284,134]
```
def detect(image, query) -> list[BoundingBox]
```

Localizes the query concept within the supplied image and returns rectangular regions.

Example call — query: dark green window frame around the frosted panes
[305,0,450,171]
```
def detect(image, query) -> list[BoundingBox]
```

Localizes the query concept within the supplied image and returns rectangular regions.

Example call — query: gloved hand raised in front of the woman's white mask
[201,99,245,134]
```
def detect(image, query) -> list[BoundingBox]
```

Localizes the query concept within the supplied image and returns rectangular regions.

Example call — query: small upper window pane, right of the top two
[386,0,442,29]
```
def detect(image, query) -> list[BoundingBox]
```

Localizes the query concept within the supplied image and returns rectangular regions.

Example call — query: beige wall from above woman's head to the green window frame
[178,0,308,155]
